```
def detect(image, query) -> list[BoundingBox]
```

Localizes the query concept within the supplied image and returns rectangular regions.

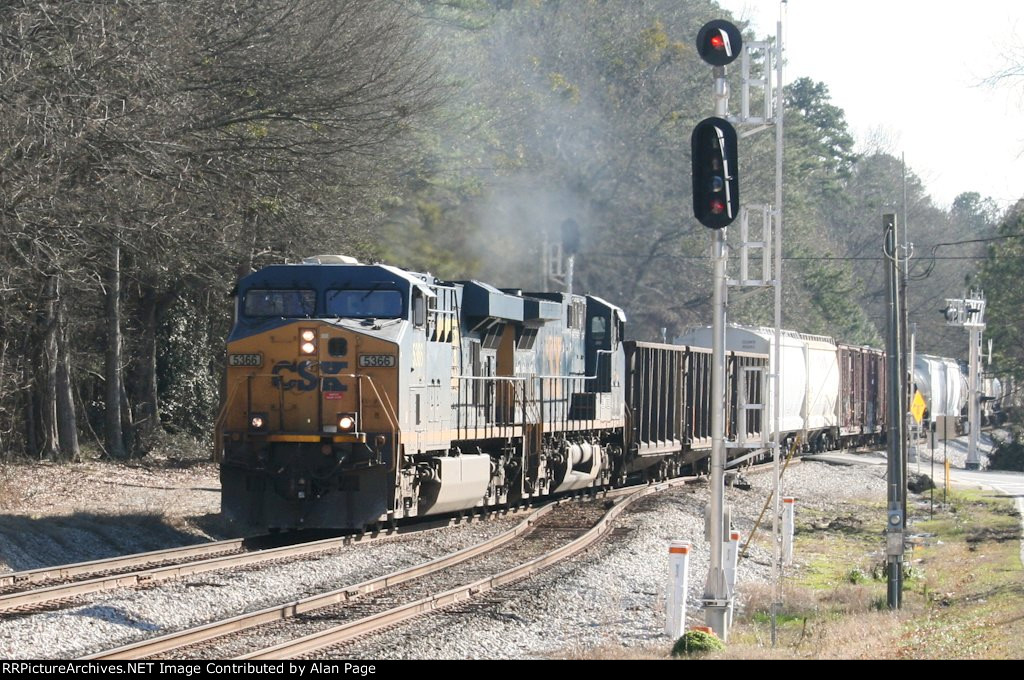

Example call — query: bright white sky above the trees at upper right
[719,0,1024,208]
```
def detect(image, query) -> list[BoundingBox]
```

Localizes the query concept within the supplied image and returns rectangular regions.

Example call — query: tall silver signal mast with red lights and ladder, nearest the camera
[690,13,784,643]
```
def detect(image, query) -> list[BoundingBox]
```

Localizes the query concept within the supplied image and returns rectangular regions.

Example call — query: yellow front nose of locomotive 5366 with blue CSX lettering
[218,320,398,527]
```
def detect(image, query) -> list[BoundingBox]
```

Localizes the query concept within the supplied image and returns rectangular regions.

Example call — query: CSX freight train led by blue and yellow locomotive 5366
[216,256,897,529]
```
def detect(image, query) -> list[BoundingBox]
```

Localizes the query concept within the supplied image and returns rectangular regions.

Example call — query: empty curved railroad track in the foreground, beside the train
[87,478,692,658]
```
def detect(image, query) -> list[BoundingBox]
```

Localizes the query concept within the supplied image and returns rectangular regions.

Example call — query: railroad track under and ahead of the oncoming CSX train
[0,518,495,618]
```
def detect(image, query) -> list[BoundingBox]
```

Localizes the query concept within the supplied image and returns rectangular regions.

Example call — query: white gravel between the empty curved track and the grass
[333,463,885,658]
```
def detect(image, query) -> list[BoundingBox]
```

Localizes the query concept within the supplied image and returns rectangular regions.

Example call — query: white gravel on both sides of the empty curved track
[0,450,905,658]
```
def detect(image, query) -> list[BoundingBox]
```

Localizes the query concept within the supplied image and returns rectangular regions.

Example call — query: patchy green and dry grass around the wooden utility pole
[567,485,1024,660]
